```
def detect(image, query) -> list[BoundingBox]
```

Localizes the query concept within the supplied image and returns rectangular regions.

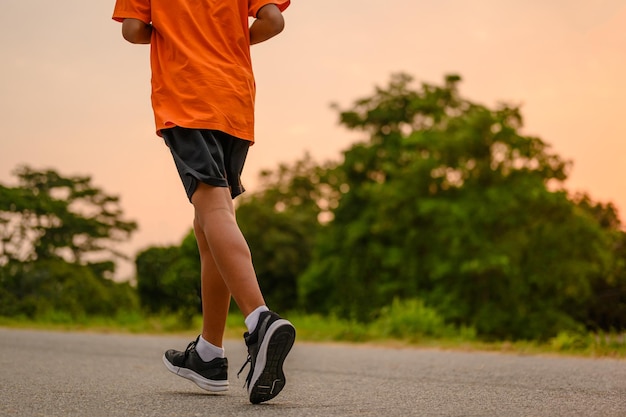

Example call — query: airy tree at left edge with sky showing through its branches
[0,166,137,273]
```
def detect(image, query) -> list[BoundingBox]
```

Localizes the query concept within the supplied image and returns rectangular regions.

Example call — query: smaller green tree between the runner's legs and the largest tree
[237,155,336,311]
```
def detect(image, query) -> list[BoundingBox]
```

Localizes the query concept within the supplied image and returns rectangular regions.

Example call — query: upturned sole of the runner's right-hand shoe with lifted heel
[249,319,296,404]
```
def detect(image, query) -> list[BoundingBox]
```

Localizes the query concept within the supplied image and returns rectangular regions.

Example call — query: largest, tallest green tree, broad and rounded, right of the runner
[299,74,614,338]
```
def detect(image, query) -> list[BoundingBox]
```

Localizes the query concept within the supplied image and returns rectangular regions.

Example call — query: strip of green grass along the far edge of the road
[0,312,626,359]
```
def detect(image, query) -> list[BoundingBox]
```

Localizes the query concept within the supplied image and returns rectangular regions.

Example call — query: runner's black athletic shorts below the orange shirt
[161,126,250,201]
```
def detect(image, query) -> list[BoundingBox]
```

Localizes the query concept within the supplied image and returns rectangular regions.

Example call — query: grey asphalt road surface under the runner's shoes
[0,329,626,417]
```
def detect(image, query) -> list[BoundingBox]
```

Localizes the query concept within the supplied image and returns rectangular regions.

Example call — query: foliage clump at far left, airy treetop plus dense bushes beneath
[0,166,137,319]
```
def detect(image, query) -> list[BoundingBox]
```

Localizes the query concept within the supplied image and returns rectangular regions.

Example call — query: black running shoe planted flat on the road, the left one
[163,336,228,392]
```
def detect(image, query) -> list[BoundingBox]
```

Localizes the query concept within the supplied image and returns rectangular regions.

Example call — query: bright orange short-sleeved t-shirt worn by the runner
[113,0,290,141]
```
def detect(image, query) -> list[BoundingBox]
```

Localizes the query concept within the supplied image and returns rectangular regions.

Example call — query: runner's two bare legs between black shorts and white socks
[191,183,265,346]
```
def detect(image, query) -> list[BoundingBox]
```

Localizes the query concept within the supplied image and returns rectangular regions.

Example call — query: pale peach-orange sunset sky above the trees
[0,0,626,278]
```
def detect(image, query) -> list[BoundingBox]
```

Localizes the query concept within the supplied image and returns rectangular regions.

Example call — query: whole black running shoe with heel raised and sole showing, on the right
[237,311,296,404]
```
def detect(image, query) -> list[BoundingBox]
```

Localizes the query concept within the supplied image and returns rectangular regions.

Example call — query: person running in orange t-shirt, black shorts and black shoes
[113,0,296,404]
